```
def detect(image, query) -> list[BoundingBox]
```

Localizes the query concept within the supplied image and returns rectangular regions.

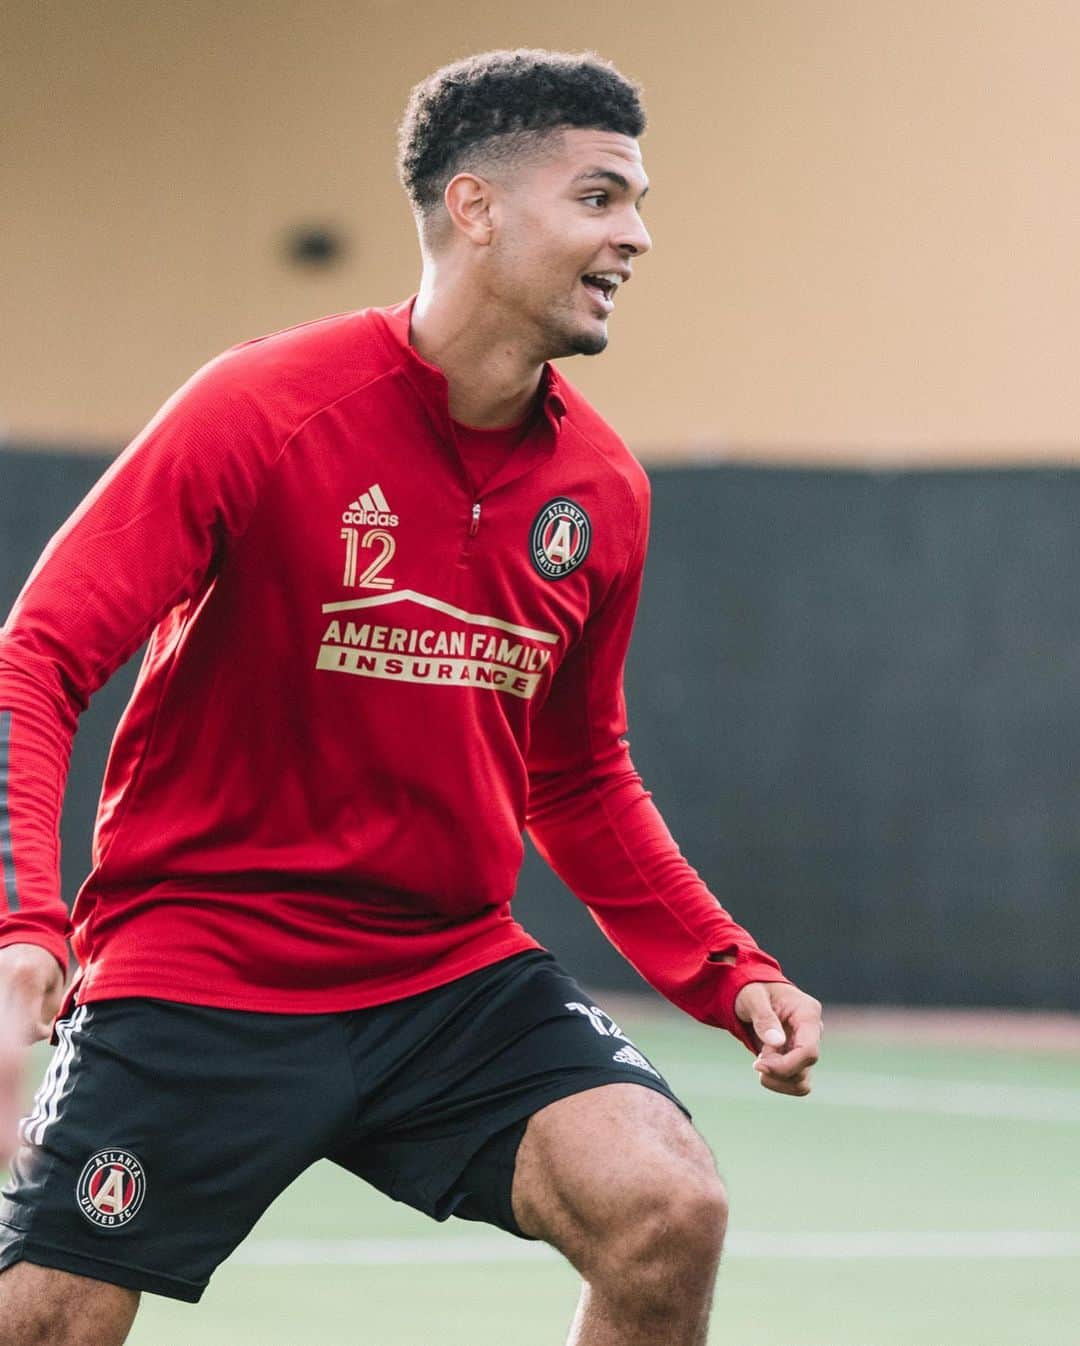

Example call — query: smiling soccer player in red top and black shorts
[0,51,820,1346]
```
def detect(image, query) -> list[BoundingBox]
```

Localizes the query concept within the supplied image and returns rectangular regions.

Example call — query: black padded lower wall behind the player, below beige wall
[0,451,1080,1008]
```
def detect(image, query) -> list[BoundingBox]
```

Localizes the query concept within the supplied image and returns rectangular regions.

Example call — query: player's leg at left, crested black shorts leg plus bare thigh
[0,999,356,1329]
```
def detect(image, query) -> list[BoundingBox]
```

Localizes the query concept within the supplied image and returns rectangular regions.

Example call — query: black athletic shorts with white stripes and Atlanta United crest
[0,950,688,1302]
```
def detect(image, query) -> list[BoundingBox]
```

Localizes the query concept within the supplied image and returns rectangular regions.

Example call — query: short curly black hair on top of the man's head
[397,47,645,214]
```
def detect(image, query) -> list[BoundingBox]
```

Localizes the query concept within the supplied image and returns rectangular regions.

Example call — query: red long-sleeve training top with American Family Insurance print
[0,303,784,1046]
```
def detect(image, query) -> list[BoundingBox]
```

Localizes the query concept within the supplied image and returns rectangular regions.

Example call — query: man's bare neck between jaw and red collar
[409,267,543,429]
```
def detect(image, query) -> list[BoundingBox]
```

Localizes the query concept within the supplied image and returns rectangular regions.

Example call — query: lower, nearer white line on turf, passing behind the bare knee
[230,1229,1080,1267]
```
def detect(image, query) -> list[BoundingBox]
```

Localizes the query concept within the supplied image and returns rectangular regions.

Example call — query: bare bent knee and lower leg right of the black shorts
[513,1084,727,1346]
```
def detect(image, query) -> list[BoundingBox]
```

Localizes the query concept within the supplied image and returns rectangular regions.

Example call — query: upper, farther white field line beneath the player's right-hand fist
[661,1059,1080,1125]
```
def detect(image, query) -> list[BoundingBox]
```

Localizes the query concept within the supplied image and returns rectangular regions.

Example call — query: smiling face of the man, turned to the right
[486,128,652,359]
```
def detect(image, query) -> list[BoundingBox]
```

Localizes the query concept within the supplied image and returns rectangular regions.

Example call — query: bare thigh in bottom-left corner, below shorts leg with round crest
[0,1263,139,1346]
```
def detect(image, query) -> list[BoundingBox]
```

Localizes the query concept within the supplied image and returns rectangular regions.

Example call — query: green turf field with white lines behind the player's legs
[14,1016,1080,1346]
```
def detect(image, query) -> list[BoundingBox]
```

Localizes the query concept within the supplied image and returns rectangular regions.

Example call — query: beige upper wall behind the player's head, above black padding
[0,0,1080,463]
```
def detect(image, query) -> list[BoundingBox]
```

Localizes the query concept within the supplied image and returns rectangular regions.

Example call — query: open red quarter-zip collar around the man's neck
[376,295,567,494]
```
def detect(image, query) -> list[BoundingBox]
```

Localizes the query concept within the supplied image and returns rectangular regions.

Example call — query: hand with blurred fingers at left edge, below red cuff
[0,944,63,1163]
